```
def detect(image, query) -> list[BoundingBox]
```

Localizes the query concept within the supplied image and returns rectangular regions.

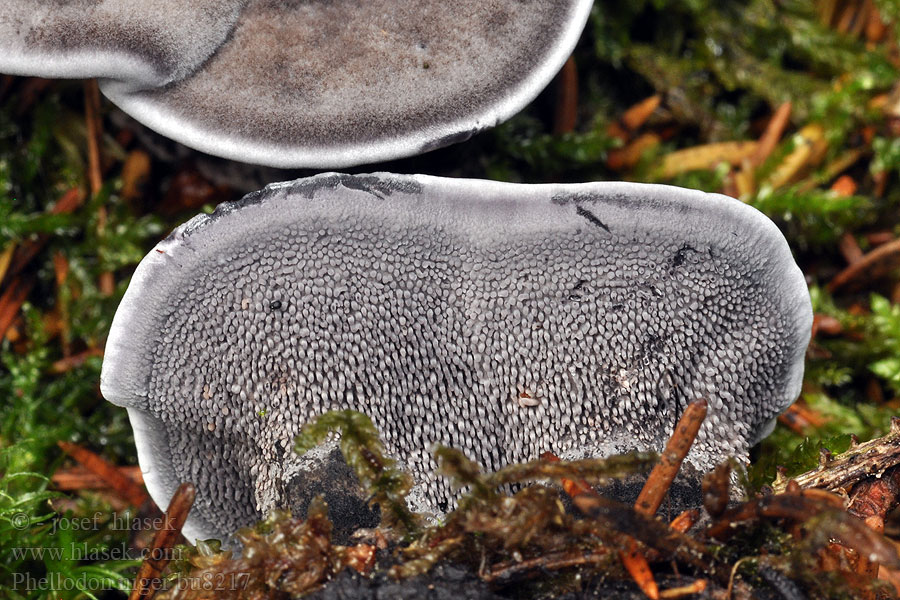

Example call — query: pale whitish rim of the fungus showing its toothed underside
[100,173,813,540]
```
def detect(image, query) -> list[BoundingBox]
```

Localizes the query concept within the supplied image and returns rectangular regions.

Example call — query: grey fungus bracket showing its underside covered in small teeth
[101,173,812,538]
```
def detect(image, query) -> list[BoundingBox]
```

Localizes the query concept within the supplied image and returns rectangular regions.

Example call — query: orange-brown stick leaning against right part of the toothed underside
[634,398,708,516]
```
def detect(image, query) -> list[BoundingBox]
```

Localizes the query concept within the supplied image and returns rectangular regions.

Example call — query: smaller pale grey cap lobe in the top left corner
[0,0,246,90]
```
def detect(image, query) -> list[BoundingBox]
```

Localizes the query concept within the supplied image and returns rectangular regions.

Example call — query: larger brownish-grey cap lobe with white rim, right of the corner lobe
[102,0,592,168]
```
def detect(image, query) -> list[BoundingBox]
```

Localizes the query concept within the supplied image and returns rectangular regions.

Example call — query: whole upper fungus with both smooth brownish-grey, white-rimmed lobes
[0,0,593,168]
